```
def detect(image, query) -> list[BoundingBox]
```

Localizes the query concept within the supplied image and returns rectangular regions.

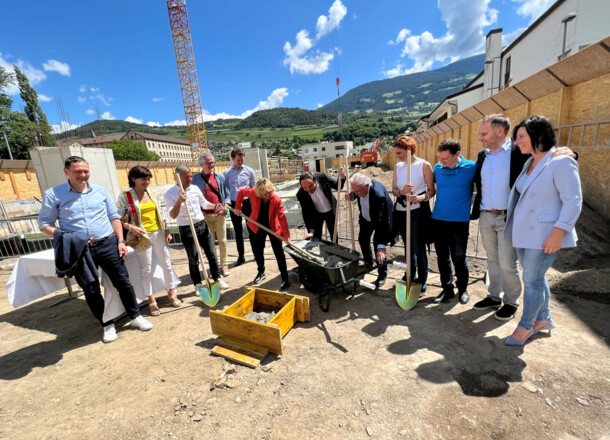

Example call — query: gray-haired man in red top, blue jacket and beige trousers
[193,153,231,277]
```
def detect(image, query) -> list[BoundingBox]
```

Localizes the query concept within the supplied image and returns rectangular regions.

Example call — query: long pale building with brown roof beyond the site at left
[57,130,191,162]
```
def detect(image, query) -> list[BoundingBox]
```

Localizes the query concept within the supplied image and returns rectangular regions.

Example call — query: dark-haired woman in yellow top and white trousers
[117,165,182,316]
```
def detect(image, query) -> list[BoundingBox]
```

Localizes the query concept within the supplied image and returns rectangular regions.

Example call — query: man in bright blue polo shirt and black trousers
[432,139,476,304]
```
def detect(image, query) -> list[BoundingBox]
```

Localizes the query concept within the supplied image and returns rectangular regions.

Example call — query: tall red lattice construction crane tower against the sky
[167,0,209,161]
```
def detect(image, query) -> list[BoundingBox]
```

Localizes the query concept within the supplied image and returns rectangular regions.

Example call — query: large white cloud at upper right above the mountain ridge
[384,0,498,78]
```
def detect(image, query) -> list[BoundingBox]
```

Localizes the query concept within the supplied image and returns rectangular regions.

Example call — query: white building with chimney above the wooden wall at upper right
[417,0,610,133]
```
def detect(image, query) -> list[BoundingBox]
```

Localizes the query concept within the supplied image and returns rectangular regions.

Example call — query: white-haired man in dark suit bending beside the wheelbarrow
[345,173,393,288]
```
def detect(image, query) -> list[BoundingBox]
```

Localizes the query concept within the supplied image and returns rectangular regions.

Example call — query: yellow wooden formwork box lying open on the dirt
[210,286,310,368]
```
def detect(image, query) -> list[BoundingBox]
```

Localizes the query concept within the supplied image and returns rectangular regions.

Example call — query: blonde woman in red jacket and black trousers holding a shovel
[235,178,290,290]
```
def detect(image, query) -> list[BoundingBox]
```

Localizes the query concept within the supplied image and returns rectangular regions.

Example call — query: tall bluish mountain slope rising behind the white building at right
[319,54,485,115]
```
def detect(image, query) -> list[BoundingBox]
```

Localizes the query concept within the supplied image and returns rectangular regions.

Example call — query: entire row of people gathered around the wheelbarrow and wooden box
[39,114,582,345]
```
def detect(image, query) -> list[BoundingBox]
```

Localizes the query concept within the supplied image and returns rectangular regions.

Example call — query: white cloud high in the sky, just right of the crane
[282,0,347,75]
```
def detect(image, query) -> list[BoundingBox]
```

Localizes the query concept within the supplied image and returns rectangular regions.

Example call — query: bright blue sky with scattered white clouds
[0,0,554,132]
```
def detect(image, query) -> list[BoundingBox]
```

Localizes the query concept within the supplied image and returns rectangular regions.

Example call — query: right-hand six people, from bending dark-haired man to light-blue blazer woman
[297,114,582,345]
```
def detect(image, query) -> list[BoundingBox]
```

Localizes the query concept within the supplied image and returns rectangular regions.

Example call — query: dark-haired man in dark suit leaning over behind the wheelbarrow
[297,169,345,239]
